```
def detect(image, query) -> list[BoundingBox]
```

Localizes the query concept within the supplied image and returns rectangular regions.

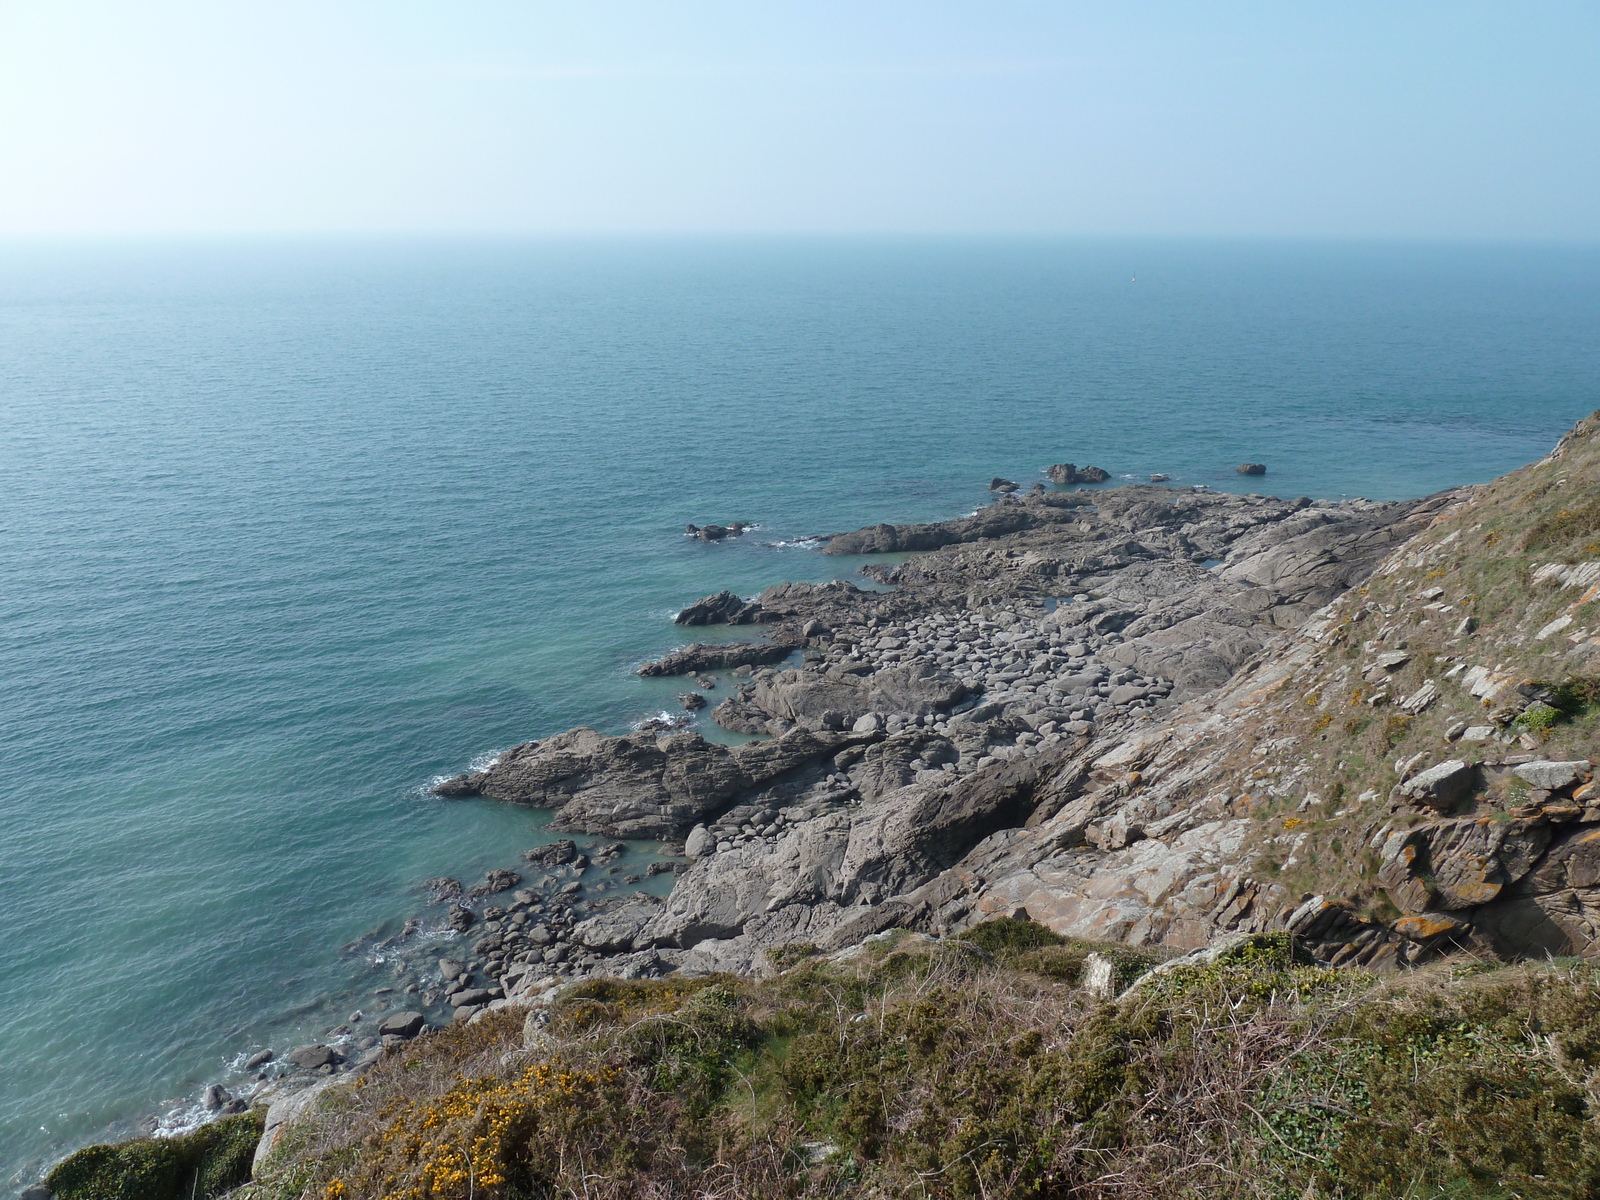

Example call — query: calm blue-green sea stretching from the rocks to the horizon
[0,238,1600,1182]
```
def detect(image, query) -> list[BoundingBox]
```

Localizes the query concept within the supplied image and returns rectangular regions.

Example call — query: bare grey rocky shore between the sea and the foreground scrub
[43,424,1600,1196]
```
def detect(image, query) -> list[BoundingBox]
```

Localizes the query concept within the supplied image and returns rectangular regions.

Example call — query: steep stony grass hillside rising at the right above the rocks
[1158,414,1600,918]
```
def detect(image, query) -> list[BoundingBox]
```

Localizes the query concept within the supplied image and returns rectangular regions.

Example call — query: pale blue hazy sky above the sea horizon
[0,0,1600,238]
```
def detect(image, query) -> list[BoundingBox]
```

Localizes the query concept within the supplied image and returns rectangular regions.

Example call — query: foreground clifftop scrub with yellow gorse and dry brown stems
[248,922,1600,1200]
